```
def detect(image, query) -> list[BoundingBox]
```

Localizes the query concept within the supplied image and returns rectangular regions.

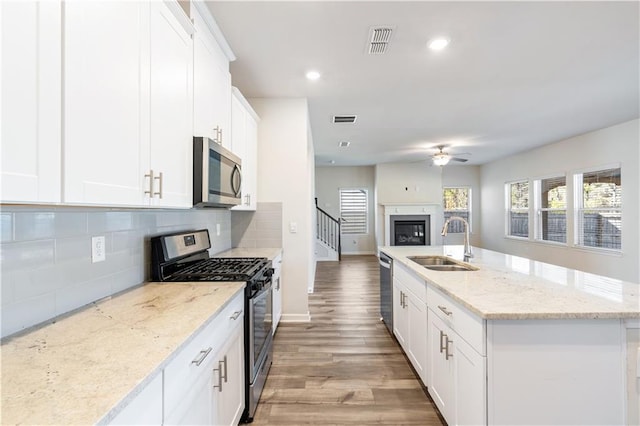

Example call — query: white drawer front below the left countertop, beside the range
[164,292,244,414]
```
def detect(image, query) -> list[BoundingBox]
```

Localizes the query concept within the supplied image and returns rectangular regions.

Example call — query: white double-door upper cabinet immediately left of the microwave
[64,1,193,207]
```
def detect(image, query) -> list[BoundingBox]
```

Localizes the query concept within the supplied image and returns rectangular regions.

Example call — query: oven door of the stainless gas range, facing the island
[249,281,273,383]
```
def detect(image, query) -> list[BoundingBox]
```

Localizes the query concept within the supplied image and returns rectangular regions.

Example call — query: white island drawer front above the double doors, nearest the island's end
[427,286,486,355]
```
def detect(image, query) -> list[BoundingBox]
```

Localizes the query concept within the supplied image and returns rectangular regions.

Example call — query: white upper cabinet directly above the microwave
[191,3,235,150]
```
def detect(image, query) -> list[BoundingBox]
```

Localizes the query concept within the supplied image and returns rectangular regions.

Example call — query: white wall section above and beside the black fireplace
[375,161,444,250]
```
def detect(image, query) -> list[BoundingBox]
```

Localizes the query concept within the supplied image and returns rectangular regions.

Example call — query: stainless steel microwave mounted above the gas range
[193,136,242,207]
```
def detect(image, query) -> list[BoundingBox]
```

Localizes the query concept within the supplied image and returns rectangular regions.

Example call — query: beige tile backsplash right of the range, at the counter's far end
[231,203,282,248]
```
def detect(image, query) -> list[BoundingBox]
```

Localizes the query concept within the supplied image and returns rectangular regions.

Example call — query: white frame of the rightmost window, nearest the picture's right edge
[573,163,624,253]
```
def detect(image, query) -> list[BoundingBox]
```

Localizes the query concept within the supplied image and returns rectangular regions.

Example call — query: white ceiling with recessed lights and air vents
[208,1,640,165]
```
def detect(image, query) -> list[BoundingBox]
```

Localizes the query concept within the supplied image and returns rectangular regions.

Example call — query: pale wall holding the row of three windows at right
[480,120,640,282]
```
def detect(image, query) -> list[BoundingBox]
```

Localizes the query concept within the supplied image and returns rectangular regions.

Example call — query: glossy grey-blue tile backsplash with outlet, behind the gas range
[0,206,231,337]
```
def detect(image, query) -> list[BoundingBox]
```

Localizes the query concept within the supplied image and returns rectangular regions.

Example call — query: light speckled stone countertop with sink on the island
[379,246,640,320]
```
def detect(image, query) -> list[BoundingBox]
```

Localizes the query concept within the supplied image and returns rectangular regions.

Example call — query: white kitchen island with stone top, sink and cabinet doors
[380,246,640,425]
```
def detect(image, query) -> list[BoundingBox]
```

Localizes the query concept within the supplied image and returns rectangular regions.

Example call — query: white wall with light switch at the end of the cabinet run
[249,98,315,321]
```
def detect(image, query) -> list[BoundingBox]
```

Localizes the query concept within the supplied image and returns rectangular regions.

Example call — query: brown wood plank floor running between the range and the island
[253,256,444,426]
